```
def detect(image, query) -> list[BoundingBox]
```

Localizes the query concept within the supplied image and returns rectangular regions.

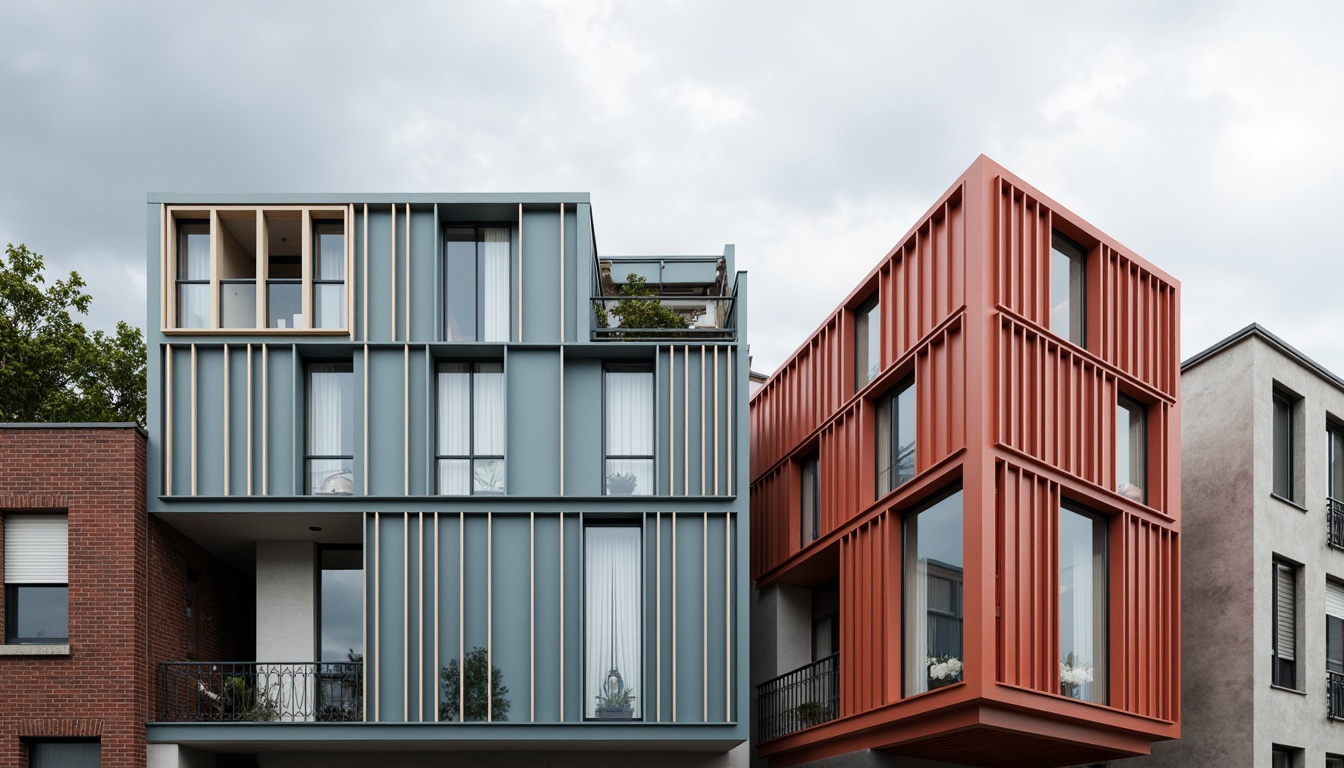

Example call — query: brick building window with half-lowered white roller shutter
[4,514,70,643]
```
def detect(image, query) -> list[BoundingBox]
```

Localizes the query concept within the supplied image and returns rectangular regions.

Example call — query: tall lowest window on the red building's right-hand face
[1059,507,1107,703]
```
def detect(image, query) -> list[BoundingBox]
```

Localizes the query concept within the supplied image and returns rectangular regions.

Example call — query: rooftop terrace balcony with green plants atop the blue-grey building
[591,257,738,342]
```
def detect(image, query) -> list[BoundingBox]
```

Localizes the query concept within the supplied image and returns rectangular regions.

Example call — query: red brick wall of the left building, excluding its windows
[0,426,245,768]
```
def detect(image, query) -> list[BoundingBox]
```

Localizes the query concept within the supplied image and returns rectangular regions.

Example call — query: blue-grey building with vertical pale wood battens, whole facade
[146,194,749,767]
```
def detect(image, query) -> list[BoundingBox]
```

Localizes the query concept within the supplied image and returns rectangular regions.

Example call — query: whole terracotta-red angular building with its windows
[750,156,1180,767]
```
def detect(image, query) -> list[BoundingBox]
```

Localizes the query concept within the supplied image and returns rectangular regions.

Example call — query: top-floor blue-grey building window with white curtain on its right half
[444,227,509,342]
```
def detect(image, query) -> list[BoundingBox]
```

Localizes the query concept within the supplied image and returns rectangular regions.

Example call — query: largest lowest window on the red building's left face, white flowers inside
[905,490,964,695]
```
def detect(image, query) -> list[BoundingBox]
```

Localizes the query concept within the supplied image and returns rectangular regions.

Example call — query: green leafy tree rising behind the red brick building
[0,243,145,426]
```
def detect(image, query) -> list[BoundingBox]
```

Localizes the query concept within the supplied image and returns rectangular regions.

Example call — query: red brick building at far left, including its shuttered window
[0,424,249,768]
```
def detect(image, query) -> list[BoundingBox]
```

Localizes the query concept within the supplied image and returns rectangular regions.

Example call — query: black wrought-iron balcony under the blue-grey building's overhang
[159,662,364,722]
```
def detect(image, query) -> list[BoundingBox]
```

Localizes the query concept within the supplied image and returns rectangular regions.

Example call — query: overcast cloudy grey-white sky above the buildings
[0,0,1344,374]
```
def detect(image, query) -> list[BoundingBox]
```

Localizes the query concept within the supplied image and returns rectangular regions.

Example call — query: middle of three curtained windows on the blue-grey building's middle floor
[438,362,504,496]
